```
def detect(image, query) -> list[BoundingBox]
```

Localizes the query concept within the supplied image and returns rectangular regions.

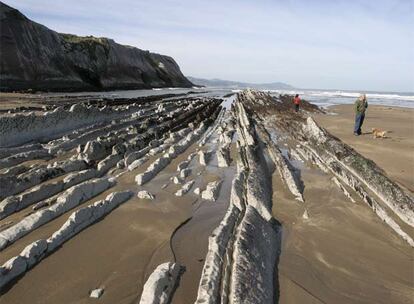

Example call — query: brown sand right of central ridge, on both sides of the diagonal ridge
[273,105,414,304]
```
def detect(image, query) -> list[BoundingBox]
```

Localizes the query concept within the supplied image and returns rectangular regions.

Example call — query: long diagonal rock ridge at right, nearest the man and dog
[296,117,414,247]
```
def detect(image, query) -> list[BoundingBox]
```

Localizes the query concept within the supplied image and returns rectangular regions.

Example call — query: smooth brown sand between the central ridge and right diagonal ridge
[273,168,414,304]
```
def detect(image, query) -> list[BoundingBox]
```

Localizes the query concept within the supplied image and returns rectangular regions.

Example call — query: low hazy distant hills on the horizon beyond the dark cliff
[187,76,294,90]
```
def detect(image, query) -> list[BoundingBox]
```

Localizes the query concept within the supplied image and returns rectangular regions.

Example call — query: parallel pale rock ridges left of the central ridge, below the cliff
[0,97,221,294]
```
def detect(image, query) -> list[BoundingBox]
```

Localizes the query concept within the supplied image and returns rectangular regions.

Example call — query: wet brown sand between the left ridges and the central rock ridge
[0,130,235,303]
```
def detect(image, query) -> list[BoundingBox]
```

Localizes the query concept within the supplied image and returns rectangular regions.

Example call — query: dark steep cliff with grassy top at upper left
[0,2,192,91]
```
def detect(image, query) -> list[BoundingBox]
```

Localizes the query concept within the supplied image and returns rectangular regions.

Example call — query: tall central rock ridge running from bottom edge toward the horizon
[196,100,281,304]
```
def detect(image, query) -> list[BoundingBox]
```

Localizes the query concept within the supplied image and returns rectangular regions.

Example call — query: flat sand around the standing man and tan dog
[313,105,414,191]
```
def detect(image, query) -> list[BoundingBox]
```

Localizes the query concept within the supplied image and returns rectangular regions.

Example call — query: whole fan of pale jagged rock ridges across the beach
[0,86,414,304]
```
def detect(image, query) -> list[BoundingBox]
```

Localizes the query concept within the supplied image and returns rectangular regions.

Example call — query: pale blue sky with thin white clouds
[4,0,414,92]
